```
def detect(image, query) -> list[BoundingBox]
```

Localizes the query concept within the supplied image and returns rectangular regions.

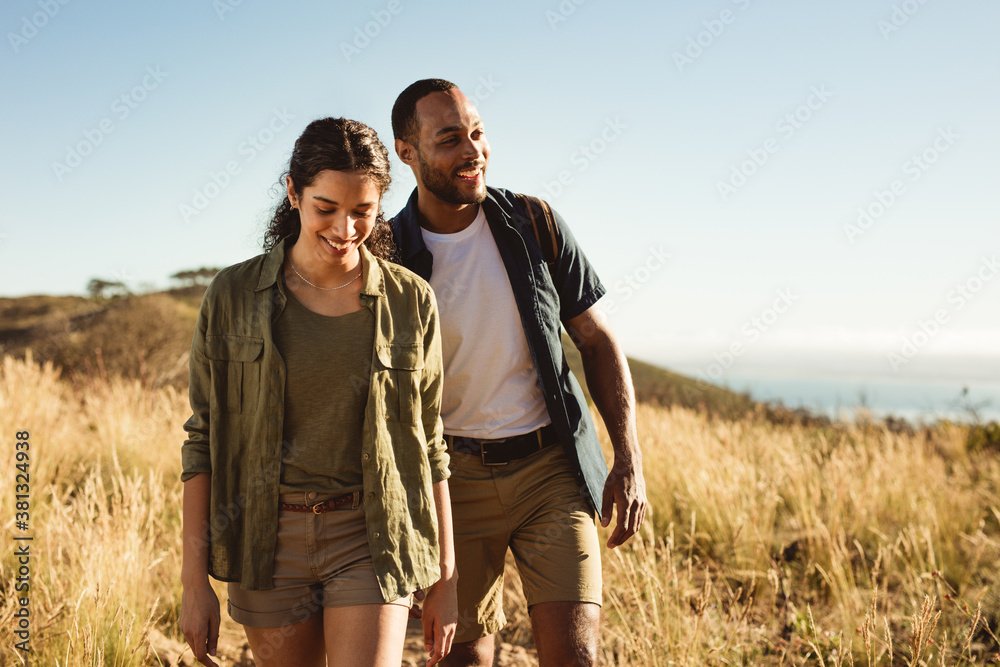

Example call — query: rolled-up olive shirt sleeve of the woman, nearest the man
[420,289,451,484]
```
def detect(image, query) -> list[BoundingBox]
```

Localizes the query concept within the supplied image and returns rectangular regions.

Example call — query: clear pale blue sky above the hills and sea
[0,0,1000,388]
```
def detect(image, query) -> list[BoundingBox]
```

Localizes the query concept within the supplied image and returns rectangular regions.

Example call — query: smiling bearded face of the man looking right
[415,88,490,204]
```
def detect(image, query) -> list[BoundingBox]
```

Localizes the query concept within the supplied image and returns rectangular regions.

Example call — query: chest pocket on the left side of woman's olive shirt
[205,335,264,413]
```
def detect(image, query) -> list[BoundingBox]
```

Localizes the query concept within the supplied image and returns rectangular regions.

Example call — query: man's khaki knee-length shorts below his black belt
[448,444,602,642]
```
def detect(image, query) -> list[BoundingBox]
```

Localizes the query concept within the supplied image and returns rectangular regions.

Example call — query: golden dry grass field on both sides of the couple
[0,356,1000,667]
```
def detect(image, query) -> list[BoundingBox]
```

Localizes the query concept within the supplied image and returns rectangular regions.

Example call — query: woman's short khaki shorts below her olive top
[228,492,412,628]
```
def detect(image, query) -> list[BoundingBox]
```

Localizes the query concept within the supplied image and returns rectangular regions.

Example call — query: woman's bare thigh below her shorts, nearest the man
[323,604,409,667]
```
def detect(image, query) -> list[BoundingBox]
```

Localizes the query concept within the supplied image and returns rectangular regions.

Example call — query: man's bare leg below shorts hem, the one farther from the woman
[530,602,601,667]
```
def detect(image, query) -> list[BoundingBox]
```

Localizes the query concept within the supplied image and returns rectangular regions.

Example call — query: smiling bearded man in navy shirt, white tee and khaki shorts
[392,79,646,666]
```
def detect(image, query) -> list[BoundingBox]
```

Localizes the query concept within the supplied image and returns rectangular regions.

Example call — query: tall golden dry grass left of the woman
[0,356,187,666]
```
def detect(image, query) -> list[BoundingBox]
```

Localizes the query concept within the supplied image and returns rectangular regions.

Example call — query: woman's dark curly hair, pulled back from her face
[262,118,395,260]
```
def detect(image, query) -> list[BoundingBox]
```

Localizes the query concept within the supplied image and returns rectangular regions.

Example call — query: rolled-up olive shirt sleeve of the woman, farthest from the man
[181,287,212,482]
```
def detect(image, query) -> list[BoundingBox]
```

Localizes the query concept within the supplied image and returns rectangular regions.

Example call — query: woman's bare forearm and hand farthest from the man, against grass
[180,472,221,667]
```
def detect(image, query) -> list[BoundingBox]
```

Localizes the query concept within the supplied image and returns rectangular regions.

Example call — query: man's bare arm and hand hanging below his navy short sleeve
[566,306,647,549]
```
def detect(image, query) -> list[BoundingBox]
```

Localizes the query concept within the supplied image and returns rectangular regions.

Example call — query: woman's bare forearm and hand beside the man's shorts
[422,480,458,667]
